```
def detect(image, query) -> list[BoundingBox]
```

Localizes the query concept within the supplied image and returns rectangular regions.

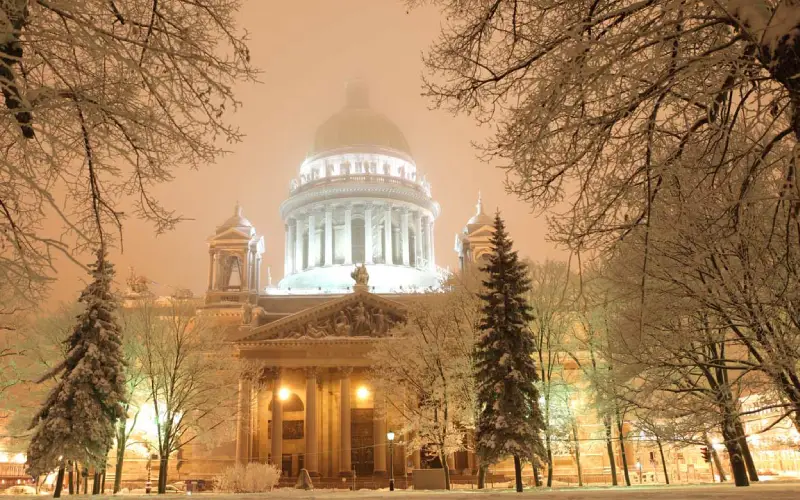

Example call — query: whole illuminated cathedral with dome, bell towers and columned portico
[202,82,492,478]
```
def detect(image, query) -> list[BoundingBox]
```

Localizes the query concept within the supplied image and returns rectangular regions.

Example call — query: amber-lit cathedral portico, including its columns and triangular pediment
[230,289,405,477]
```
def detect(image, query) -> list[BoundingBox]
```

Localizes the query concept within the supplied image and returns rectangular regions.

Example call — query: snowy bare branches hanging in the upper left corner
[0,0,255,302]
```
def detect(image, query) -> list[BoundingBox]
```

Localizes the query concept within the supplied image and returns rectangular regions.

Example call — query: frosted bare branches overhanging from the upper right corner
[418,0,800,254]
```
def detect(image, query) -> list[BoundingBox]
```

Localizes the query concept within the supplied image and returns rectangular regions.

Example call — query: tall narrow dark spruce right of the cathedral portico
[475,212,544,491]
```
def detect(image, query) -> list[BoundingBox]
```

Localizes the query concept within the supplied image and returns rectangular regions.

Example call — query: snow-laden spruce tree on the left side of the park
[28,250,126,482]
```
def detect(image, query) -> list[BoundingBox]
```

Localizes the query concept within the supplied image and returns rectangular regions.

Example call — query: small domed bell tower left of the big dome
[206,203,264,304]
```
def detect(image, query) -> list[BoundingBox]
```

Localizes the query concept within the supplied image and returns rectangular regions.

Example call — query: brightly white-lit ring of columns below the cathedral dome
[284,201,435,275]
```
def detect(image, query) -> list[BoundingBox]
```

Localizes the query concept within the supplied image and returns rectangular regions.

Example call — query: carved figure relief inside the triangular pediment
[265,301,402,340]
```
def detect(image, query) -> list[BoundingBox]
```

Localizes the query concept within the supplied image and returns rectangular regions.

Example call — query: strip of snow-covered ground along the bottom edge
[5,483,800,500]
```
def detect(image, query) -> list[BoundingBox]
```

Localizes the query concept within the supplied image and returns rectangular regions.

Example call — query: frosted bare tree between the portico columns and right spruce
[370,288,480,489]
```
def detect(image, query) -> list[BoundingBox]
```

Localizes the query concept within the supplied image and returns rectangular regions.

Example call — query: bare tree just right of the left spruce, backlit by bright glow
[133,298,238,493]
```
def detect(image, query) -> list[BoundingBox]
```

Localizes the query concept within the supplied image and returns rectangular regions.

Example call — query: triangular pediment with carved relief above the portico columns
[238,292,406,342]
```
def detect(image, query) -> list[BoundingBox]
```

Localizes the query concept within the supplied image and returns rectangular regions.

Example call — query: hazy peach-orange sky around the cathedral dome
[50,0,565,305]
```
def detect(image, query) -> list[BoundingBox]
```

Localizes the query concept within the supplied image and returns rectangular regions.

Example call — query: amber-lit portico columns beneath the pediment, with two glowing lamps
[236,367,420,478]
